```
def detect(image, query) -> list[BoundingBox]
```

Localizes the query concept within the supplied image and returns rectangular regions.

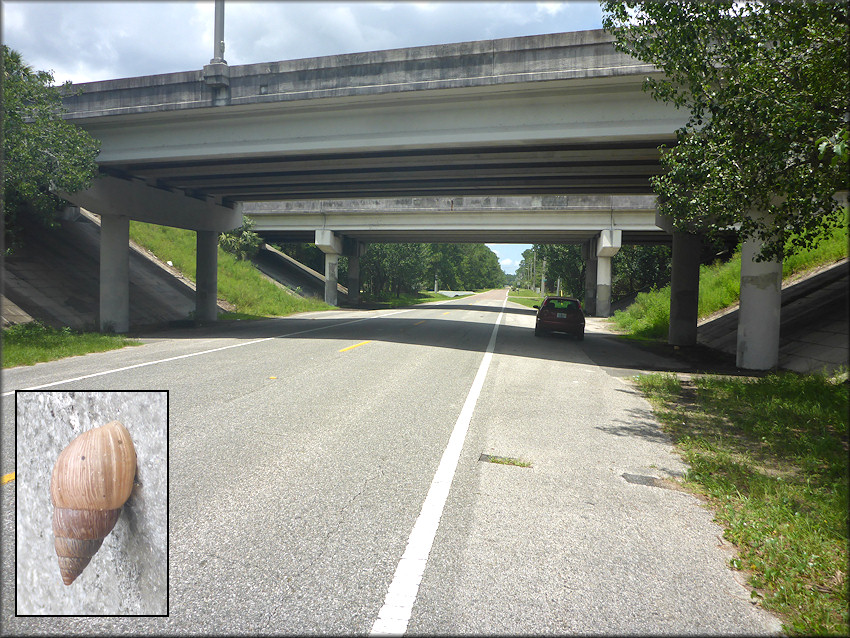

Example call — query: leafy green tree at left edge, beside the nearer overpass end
[2,45,100,253]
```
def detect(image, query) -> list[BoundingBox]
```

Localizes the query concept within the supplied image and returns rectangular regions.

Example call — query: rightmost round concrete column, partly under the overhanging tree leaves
[735,220,782,370]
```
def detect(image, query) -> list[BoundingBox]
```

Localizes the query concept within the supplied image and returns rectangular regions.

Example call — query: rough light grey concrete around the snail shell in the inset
[15,391,168,615]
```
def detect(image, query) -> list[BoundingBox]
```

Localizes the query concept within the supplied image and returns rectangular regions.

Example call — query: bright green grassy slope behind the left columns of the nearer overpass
[130,221,331,319]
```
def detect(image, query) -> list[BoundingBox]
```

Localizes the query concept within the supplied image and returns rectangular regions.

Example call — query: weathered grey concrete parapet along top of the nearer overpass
[63,29,657,120]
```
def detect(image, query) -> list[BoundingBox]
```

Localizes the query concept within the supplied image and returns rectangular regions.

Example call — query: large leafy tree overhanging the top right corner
[603,0,850,259]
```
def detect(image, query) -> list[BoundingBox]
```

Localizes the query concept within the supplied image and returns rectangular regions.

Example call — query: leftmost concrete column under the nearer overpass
[100,215,130,332]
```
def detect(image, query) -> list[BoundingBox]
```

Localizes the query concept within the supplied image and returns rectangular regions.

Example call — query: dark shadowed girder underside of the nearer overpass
[101,141,674,203]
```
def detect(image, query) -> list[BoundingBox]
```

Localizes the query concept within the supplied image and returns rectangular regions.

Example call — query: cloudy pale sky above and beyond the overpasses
[0,0,602,274]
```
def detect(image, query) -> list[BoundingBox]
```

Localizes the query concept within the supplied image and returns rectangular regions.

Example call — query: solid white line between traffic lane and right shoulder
[371,295,508,636]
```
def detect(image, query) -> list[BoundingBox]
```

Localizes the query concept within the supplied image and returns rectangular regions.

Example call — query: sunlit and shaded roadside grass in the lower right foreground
[637,372,850,635]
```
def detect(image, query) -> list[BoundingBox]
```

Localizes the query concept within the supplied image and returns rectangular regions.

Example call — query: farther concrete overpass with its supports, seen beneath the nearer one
[243,195,671,316]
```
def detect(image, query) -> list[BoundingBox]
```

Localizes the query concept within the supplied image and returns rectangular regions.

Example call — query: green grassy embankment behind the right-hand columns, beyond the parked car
[612,214,848,339]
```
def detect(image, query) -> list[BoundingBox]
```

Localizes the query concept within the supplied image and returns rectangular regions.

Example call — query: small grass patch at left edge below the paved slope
[3,321,141,368]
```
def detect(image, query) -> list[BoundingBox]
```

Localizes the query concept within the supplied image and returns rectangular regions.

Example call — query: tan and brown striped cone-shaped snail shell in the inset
[50,421,136,585]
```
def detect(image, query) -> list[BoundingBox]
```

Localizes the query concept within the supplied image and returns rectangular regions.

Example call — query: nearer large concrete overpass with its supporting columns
[54,30,778,367]
